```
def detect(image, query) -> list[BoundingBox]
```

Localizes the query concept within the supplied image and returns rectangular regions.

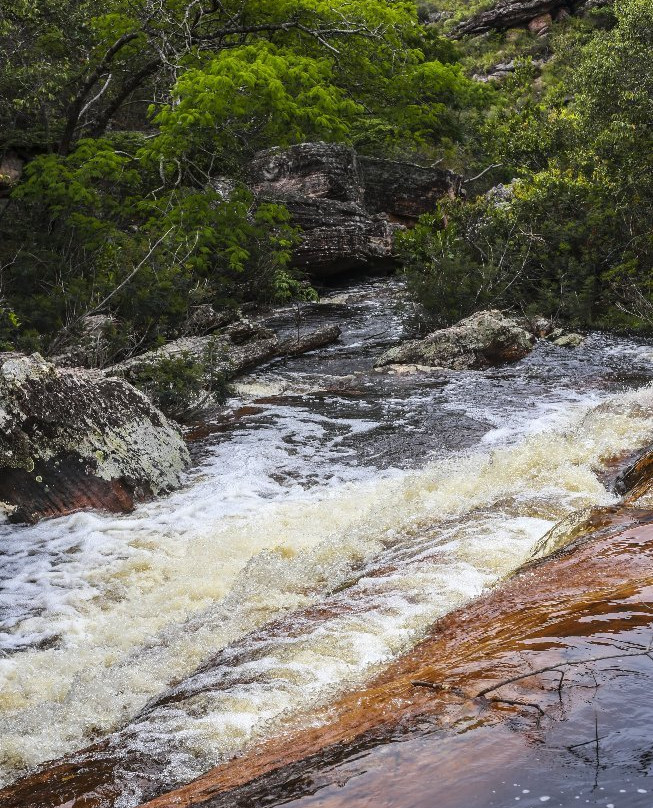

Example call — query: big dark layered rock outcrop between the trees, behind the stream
[250,143,462,277]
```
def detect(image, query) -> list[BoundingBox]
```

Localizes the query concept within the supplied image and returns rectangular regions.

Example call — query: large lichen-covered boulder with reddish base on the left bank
[0,354,189,522]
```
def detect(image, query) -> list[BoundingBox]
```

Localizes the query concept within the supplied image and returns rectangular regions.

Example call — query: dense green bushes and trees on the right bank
[404,0,653,329]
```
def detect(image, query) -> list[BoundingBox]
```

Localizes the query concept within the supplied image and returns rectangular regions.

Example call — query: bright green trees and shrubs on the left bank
[0,0,482,353]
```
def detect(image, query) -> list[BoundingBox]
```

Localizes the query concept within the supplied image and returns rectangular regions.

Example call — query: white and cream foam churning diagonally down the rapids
[0,388,653,782]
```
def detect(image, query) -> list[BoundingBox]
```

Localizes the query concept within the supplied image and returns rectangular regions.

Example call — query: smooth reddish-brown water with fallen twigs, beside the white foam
[139,509,653,808]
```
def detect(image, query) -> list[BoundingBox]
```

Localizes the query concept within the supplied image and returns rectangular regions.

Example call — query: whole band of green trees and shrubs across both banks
[0,0,653,358]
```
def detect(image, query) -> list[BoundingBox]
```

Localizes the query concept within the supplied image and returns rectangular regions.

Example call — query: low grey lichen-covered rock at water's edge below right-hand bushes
[375,311,535,370]
